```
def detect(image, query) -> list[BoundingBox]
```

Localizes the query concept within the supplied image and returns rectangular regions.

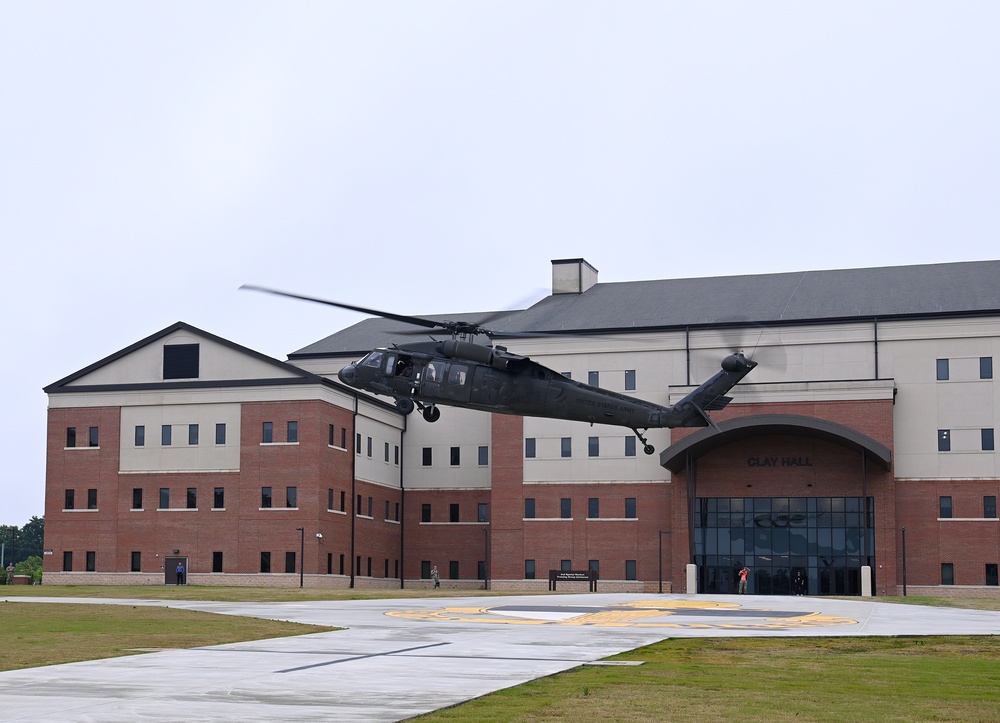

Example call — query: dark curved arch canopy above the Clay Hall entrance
[660,414,892,474]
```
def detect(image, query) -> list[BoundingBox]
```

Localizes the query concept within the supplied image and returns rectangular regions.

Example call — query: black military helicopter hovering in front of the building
[241,285,757,454]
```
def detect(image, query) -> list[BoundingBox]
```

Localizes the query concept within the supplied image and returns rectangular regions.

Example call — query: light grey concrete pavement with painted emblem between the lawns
[0,594,1000,723]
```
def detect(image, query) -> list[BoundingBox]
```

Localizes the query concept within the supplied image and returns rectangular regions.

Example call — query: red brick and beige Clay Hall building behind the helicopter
[45,259,1000,595]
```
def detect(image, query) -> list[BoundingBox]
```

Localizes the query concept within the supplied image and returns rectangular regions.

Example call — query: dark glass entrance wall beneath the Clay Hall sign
[694,497,875,595]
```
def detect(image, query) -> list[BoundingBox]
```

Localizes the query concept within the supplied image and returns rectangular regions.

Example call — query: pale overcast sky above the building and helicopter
[0,0,1000,525]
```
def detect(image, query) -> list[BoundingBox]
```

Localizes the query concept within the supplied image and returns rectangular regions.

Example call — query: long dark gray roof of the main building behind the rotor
[289,261,1000,359]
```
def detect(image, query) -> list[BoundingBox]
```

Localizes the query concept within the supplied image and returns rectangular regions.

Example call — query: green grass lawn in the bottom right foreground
[420,636,1000,723]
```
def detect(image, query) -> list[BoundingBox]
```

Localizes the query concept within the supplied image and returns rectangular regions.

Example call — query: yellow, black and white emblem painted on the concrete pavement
[386,600,858,630]
